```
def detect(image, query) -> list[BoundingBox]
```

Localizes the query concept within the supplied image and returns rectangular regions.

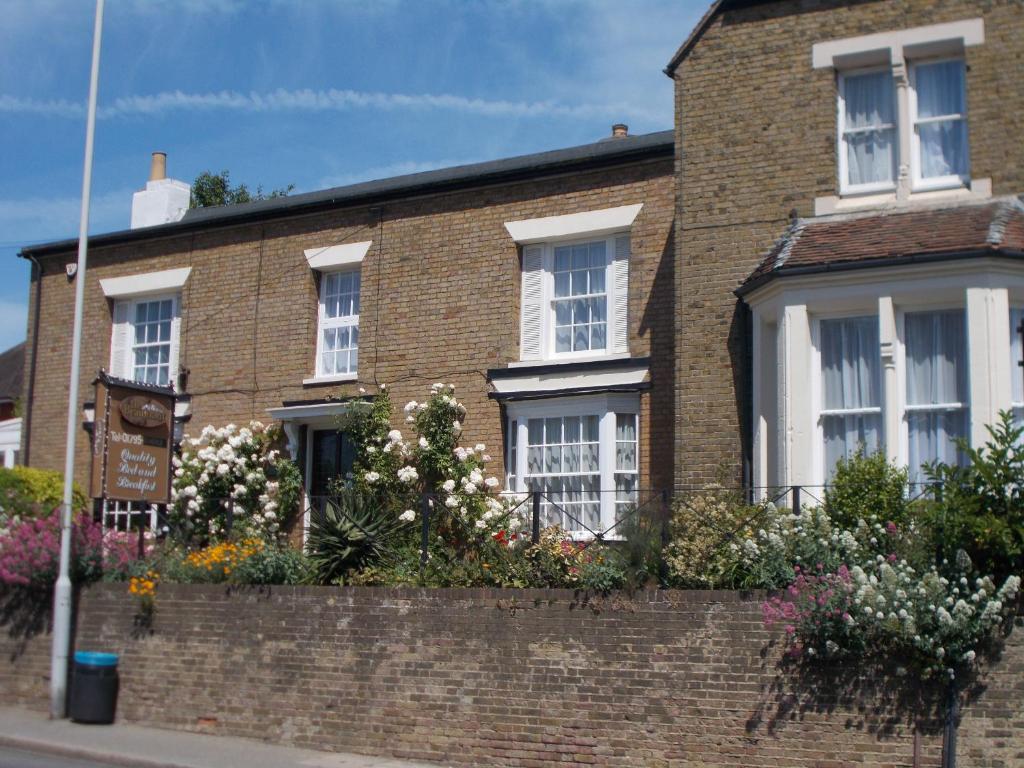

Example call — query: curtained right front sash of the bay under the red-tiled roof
[904,310,968,482]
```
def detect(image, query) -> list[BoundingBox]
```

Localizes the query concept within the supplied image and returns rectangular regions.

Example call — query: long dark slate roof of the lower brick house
[19,130,675,257]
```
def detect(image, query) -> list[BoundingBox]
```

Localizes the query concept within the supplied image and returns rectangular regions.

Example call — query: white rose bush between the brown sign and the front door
[168,421,301,543]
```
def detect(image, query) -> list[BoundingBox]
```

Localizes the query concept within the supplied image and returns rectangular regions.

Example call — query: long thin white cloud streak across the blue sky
[0,88,654,120]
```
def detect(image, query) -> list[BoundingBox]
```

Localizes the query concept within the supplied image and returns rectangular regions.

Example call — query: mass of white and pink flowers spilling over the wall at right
[757,450,1021,679]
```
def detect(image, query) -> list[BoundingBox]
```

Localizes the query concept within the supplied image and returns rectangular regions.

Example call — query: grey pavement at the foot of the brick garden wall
[0,707,448,768]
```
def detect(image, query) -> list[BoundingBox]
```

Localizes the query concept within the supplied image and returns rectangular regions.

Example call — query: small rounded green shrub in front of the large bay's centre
[825,450,911,528]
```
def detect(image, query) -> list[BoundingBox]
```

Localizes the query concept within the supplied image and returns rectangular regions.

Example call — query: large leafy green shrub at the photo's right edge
[927,412,1024,582]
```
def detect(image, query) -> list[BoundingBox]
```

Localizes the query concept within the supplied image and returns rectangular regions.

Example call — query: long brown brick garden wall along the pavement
[0,585,1024,768]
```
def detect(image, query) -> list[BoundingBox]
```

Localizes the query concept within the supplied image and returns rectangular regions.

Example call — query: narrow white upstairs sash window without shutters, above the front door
[316,269,359,377]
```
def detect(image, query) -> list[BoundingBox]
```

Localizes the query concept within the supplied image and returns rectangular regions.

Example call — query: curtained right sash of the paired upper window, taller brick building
[914,61,968,178]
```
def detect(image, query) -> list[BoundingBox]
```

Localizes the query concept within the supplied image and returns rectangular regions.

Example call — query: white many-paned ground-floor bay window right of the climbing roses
[506,394,639,537]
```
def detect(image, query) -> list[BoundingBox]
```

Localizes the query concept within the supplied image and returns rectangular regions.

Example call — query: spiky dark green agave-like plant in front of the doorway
[306,492,400,584]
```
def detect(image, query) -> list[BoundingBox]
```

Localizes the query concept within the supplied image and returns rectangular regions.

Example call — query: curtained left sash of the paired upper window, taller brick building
[843,72,896,184]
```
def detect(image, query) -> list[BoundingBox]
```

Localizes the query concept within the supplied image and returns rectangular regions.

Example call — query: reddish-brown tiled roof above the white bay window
[740,198,1024,293]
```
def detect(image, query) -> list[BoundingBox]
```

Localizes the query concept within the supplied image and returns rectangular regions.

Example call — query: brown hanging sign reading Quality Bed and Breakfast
[90,372,174,504]
